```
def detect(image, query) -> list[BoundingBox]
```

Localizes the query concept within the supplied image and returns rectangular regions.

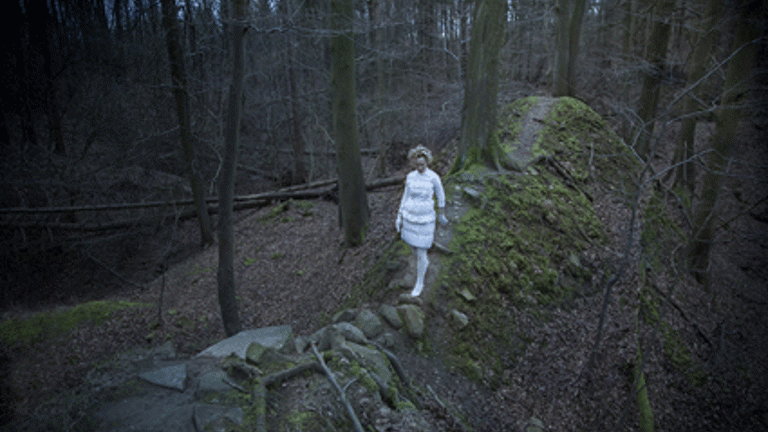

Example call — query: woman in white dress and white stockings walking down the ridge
[395,145,448,297]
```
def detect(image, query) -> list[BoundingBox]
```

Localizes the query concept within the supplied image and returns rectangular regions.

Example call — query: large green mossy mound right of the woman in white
[434,98,636,384]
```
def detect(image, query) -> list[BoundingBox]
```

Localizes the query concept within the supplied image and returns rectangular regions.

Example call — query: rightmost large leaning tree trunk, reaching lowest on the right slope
[688,0,764,283]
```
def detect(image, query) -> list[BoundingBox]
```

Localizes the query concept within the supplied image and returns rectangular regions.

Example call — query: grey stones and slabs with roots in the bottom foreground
[96,298,438,432]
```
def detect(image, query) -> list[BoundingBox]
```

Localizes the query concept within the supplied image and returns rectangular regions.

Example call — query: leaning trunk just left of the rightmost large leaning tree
[674,0,723,196]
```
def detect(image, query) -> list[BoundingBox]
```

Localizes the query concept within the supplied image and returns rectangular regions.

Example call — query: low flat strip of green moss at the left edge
[0,300,151,345]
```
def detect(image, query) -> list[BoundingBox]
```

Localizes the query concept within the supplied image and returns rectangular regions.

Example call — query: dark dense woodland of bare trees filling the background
[0,0,768,320]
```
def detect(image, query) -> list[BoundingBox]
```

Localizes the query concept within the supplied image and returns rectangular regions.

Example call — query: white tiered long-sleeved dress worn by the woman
[399,168,445,249]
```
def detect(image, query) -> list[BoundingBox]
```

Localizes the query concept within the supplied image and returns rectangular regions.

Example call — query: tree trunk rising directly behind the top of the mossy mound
[552,0,586,97]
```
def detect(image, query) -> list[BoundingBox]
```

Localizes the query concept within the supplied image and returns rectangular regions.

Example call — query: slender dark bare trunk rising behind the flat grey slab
[218,0,248,336]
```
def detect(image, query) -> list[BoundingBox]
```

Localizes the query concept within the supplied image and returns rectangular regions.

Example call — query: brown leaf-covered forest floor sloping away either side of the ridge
[3,120,768,431]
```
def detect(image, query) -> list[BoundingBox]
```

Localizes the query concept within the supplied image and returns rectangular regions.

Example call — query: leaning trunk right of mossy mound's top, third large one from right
[630,0,675,159]
